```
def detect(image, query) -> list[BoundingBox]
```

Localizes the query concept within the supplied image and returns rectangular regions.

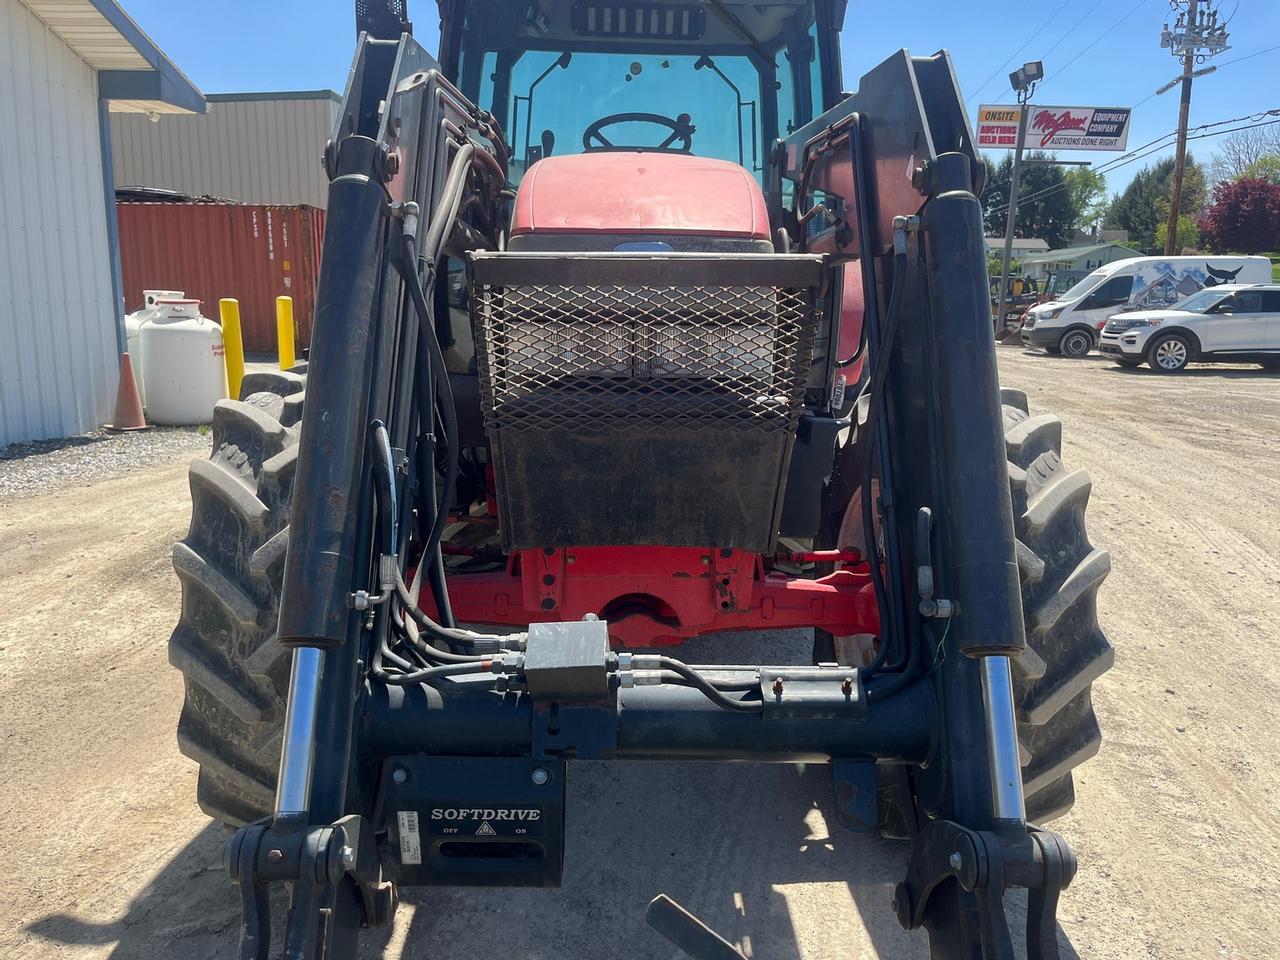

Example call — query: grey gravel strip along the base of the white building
[0,426,209,503]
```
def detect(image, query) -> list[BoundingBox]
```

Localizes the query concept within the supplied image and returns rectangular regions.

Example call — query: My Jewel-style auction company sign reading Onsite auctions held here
[978,104,1130,150]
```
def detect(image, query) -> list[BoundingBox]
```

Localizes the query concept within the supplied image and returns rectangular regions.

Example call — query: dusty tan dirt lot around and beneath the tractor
[0,348,1280,960]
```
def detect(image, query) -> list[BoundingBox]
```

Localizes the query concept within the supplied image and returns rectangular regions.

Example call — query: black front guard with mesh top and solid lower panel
[471,252,822,550]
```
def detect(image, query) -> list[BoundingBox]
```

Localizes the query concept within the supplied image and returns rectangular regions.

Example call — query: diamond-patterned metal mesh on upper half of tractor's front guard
[472,261,815,434]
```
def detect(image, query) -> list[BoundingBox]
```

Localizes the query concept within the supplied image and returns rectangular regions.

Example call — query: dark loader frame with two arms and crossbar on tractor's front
[228,9,1075,960]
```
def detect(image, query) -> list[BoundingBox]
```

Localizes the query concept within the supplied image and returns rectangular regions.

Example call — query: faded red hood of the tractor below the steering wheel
[511,152,769,239]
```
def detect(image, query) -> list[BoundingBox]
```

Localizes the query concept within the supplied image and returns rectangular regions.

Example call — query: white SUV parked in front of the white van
[1098,283,1280,374]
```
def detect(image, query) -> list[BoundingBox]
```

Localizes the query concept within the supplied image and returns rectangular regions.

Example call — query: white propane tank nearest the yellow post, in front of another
[140,297,227,426]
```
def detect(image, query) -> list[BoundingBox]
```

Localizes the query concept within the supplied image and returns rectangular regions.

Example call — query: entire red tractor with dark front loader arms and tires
[170,0,1112,960]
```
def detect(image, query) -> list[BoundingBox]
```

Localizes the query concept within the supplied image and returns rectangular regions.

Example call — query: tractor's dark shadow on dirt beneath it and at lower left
[23,631,1078,960]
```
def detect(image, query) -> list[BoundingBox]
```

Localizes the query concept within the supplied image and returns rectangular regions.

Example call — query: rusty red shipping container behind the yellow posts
[115,202,324,355]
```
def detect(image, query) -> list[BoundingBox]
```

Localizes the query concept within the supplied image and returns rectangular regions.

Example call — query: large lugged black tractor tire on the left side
[169,372,305,826]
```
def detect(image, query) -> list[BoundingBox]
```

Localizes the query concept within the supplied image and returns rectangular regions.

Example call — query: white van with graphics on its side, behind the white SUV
[1021,256,1271,357]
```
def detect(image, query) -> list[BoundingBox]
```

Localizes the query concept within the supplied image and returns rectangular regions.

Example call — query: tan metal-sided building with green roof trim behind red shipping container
[111,90,342,210]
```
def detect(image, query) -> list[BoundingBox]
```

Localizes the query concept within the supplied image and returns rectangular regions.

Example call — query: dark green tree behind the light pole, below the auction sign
[982,150,1076,250]
